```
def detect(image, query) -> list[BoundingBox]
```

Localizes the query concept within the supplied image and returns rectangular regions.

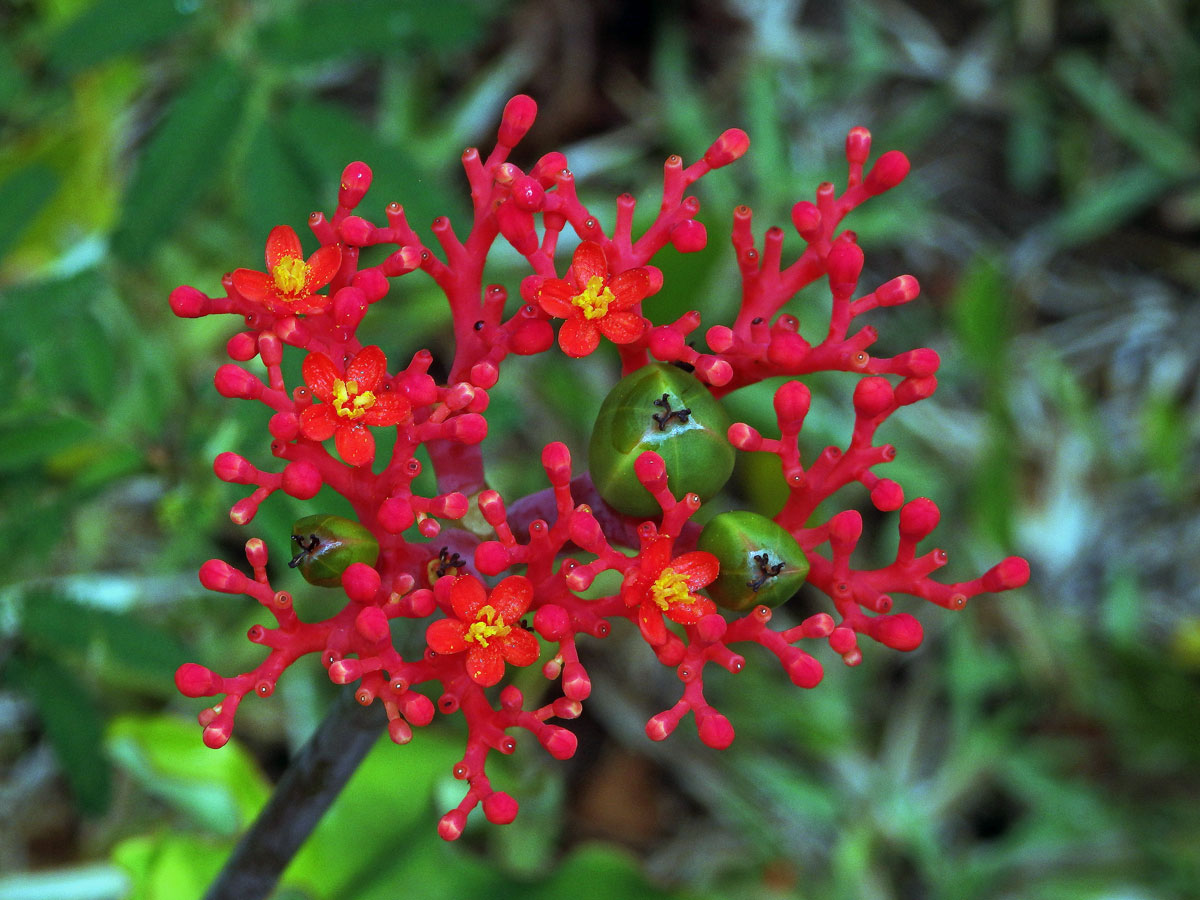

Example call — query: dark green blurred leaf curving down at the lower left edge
[6,653,112,815]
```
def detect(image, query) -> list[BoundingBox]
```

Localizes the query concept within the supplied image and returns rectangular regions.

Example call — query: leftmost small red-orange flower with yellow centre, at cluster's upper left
[233,226,342,316]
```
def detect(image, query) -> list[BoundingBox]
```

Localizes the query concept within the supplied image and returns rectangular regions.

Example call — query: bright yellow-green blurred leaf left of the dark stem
[104,715,270,835]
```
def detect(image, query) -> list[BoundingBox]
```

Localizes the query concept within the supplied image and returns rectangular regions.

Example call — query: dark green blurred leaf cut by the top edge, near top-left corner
[46,0,196,73]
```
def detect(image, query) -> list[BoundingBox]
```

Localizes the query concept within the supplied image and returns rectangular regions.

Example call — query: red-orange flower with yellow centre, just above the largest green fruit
[538,241,650,356]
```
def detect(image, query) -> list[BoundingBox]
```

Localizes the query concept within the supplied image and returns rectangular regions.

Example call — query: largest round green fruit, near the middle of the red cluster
[588,362,733,517]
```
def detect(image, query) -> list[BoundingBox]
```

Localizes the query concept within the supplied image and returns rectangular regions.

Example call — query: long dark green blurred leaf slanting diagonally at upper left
[113,59,246,260]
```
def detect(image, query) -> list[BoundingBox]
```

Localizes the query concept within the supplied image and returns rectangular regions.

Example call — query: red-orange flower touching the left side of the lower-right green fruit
[622,538,721,647]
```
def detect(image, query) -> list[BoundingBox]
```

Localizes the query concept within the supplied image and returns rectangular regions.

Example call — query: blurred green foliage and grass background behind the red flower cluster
[0,0,1200,900]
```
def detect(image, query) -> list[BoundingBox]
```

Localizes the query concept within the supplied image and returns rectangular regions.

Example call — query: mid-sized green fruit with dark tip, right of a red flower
[696,510,809,612]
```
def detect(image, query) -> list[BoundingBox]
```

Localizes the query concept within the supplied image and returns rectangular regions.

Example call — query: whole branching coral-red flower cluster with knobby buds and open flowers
[170,96,1030,840]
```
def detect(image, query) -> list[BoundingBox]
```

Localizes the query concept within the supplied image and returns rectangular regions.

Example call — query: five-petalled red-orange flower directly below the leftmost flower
[300,347,410,466]
